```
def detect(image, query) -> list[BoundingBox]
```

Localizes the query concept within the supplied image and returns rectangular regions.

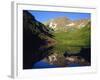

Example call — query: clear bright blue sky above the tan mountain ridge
[29,10,91,22]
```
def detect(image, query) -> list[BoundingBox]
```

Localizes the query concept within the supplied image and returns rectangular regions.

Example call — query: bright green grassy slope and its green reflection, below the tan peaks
[54,26,90,53]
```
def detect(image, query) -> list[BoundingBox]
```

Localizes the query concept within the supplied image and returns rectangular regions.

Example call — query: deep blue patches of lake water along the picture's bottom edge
[33,61,80,69]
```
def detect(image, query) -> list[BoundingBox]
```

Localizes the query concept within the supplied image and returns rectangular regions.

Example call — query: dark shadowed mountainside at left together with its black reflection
[23,10,54,69]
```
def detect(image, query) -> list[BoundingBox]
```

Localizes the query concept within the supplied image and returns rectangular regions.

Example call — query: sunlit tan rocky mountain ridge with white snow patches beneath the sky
[44,17,90,32]
